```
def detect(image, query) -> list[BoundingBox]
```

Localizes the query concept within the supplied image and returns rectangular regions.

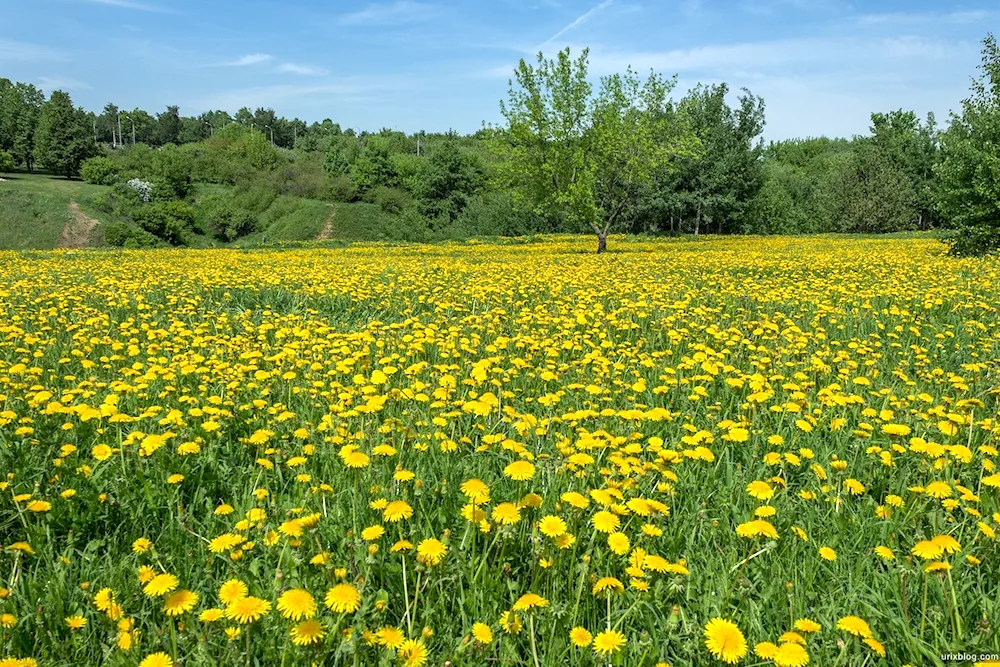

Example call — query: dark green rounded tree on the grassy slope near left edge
[35,91,98,178]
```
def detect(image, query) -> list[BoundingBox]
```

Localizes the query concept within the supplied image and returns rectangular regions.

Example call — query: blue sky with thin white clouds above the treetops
[0,0,1000,139]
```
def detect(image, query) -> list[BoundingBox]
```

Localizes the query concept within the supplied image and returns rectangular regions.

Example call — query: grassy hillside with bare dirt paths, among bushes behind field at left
[0,173,406,250]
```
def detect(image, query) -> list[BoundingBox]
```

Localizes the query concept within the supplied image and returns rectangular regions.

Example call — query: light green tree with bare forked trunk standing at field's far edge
[490,49,698,253]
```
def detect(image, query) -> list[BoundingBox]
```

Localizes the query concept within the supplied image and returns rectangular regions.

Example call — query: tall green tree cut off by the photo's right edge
[936,34,1000,255]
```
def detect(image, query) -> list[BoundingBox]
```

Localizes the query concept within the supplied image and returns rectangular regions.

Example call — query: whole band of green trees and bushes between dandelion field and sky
[0,35,1000,254]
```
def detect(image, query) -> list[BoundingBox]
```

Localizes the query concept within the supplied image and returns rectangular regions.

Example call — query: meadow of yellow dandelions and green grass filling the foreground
[0,238,1000,667]
